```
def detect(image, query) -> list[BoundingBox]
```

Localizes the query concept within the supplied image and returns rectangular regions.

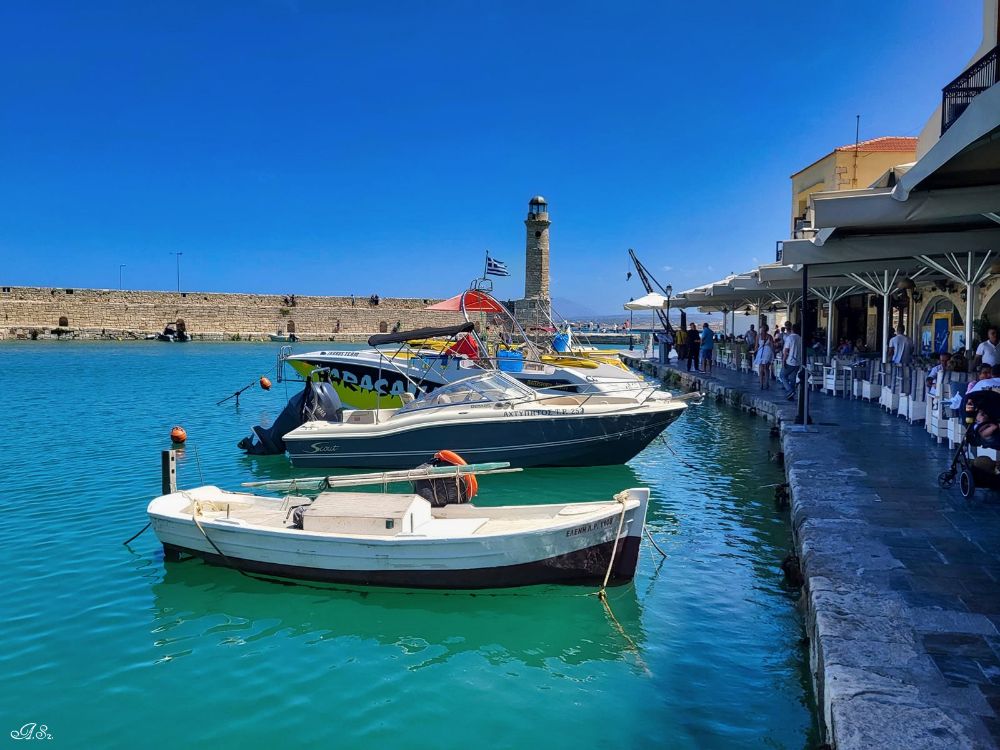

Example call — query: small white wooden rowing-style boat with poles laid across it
[148,466,649,589]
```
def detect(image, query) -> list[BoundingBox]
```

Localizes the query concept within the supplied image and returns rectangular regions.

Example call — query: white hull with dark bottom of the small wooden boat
[148,488,649,588]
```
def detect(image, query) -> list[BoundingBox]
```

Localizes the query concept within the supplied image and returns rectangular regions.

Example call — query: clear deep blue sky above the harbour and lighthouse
[0,0,982,312]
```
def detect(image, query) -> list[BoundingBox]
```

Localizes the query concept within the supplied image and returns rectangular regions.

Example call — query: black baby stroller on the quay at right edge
[938,390,1000,500]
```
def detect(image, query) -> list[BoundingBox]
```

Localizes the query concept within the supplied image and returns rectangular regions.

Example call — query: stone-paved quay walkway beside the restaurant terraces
[622,352,1000,750]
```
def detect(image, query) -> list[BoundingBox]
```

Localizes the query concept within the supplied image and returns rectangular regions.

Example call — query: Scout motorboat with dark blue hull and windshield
[283,372,687,468]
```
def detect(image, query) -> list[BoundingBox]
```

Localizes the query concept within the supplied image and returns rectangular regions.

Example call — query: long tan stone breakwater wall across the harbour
[0,287,463,341]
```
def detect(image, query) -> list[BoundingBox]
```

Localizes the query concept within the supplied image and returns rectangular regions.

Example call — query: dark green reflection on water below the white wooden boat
[150,560,645,670]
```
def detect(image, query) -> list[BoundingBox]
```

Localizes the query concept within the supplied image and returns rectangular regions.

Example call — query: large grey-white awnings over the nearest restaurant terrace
[781,85,1000,360]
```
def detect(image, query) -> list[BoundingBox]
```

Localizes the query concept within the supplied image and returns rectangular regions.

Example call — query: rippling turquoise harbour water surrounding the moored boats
[0,342,815,750]
